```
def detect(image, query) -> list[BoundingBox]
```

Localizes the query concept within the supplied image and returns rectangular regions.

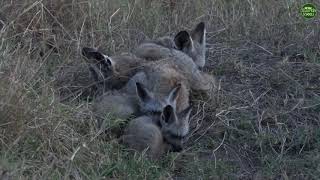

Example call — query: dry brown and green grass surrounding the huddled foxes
[0,0,320,179]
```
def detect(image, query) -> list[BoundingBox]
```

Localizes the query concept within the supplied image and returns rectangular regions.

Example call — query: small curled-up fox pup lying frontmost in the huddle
[122,105,191,159]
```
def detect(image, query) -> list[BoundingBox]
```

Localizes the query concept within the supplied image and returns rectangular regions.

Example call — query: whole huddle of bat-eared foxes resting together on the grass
[75,22,214,158]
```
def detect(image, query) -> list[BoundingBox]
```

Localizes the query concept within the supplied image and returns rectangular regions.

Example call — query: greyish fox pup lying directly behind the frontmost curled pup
[93,79,181,127]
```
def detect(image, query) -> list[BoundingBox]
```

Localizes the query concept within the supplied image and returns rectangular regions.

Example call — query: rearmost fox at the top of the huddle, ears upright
[134,22,206,68]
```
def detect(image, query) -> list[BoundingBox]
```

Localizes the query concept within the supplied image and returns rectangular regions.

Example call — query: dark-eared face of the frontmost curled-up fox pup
[160,105,191,152]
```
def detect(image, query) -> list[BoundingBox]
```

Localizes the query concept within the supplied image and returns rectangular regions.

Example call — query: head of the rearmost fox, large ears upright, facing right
[174,22,206,68]
